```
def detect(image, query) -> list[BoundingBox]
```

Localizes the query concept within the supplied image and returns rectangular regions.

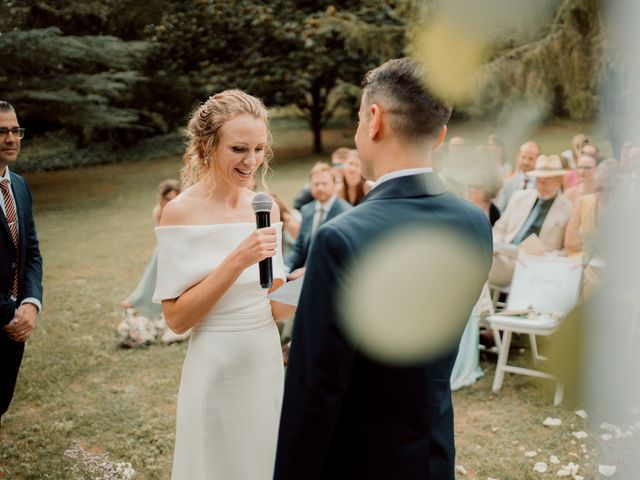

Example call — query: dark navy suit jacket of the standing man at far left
[0,172,42,325]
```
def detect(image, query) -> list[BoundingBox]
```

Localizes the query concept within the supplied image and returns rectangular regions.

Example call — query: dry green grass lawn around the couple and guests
[0,118,624,480]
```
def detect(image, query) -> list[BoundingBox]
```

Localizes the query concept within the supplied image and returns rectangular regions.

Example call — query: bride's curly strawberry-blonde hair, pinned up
[180,89,272,188]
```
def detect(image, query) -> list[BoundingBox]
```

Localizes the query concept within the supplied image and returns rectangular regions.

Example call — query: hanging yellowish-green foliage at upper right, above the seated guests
[467,0,603,120]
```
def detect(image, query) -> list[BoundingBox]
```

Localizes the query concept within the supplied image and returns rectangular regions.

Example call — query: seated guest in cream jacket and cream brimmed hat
[489,155,571,286]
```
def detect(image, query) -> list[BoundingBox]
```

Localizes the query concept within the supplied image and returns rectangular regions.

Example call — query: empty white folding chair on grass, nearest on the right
[487,255,582,405]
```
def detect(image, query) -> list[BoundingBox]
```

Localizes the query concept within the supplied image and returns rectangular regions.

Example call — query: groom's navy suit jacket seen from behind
[274,173,492,480]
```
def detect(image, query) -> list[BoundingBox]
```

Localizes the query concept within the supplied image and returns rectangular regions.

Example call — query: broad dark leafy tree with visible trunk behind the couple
[150,0,403,152]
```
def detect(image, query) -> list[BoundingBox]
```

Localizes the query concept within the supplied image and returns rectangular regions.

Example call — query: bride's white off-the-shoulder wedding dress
[154,223,285,480]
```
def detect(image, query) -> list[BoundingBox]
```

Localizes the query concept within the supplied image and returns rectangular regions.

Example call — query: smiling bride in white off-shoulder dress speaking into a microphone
[154,90,285,480]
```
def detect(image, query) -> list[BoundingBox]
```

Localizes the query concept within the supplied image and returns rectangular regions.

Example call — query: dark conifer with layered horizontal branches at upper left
[0,27,163,143]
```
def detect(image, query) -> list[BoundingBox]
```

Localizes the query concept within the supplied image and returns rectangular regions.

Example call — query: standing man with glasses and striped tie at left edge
[0,100,42,419]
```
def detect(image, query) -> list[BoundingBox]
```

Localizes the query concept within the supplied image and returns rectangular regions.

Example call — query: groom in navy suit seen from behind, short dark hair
[274,58,492,480]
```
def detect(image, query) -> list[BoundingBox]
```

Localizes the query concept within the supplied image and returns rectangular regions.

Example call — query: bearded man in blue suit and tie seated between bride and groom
[285,162,351,280]
